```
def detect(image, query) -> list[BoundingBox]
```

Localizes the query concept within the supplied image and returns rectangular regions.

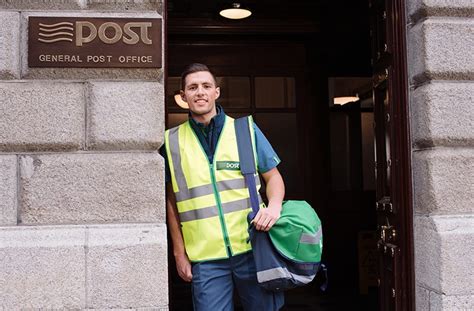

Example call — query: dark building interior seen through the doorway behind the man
[166,0,378,310]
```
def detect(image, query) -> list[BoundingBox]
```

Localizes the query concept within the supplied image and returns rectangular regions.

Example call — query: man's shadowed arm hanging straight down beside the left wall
[166,183,193,282]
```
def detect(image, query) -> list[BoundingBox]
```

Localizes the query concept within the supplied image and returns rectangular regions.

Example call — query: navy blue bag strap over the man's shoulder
[234,116,260,219]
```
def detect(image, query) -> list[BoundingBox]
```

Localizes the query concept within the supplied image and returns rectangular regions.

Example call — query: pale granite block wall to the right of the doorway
[407,0,474,311]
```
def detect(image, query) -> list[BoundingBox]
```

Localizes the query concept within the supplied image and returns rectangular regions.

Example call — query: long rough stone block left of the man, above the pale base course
[19,152,165,224]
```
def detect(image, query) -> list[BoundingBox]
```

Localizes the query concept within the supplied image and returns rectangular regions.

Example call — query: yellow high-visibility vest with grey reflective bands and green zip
[165,116,264,262]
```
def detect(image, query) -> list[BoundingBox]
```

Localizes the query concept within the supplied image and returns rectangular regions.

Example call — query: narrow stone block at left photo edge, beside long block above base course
[0,155,17,226]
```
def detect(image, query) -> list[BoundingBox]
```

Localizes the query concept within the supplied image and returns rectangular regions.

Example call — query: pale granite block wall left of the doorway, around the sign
[0,0,168,310]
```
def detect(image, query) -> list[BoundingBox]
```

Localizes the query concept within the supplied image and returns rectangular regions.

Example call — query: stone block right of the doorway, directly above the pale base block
[412,148,474,214]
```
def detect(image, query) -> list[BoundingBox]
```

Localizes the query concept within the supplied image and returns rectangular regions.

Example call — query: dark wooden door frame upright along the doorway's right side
[370,0,415,310]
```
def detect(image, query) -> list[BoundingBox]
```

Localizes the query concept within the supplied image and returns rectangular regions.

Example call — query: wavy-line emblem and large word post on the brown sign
[38,21,153,46]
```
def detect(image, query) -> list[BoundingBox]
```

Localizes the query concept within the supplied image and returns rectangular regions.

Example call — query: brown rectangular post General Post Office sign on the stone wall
[28,17,162,68]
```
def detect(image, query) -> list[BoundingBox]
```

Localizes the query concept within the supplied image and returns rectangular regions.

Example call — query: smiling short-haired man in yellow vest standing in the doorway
[164,64,285,311]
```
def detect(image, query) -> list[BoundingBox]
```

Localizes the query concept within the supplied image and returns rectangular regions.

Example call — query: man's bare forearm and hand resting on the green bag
[253,167,285,231]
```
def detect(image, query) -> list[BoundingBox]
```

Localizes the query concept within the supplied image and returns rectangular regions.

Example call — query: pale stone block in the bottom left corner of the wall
[0,227,86,310]
